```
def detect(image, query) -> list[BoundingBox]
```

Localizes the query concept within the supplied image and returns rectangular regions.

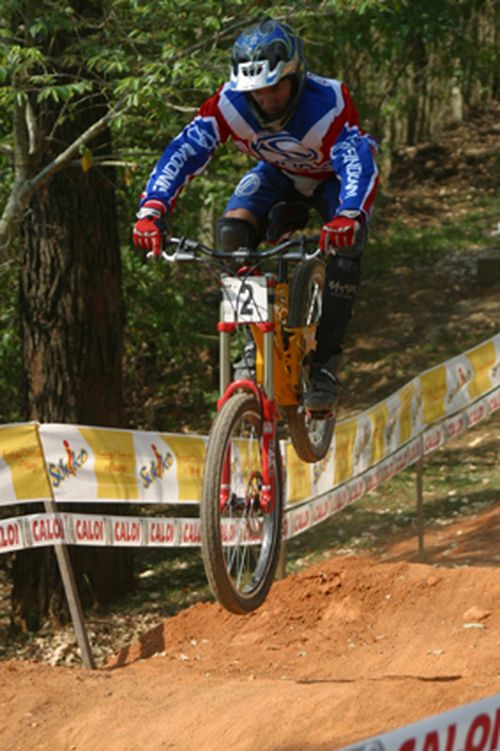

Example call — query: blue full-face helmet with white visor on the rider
[230,18,306,127]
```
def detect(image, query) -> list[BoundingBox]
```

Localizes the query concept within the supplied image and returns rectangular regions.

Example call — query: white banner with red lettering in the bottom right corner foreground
[336,694,500,751]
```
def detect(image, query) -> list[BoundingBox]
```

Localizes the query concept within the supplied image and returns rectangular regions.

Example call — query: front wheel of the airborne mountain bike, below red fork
[200,393,283,614]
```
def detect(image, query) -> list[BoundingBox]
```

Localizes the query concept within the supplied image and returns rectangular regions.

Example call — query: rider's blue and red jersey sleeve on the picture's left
[140,87,229,211]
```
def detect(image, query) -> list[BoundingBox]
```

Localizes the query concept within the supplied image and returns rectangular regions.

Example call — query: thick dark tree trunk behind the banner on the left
[12,1,133,630]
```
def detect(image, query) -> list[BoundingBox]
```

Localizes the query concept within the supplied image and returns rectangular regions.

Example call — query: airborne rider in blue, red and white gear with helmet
[133,17,378,415]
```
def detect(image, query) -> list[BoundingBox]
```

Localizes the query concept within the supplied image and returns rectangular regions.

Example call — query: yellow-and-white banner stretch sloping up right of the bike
[286,334,500,505]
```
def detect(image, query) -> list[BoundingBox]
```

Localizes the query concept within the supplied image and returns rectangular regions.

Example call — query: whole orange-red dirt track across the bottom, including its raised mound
[0,506,500,751]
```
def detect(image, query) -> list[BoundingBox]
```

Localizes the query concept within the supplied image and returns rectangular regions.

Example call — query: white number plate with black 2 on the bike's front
[222,276,269,323]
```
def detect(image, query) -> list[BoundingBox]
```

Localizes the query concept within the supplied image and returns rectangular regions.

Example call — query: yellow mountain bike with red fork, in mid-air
[150,236,335,614]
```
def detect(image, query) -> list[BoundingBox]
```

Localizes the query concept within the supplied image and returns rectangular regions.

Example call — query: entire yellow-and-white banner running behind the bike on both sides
[0,334,500,516]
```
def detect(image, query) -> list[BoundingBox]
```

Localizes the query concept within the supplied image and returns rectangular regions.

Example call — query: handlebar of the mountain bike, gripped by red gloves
[146,235,321,263]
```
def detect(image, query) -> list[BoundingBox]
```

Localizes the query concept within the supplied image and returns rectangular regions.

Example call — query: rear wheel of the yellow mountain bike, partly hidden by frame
[285,258,335,463]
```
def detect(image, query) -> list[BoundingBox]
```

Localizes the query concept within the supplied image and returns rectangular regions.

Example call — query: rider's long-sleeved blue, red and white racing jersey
[141,73,378,216]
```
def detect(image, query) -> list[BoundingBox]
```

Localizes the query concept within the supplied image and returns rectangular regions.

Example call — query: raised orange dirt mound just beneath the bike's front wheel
[111,556,500,682]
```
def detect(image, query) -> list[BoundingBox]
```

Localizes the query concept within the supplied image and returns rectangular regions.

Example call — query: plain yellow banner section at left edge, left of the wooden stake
[0,423,52,505]
